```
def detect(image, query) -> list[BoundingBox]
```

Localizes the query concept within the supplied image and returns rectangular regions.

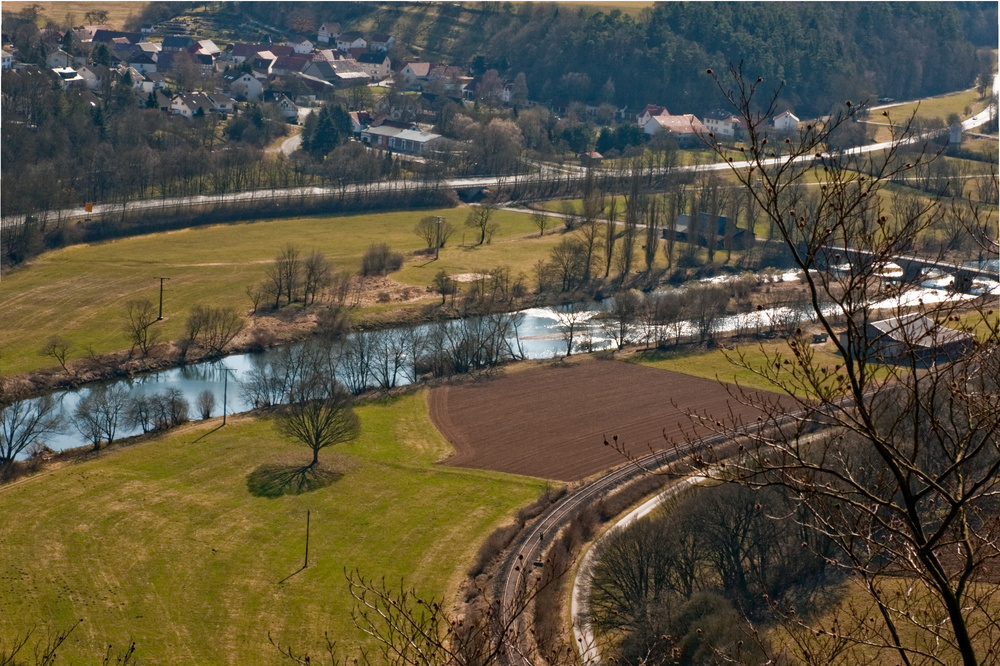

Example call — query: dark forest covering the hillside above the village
[238,2,997,117]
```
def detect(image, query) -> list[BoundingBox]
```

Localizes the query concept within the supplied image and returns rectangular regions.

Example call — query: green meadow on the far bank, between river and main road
[0,208,561,374]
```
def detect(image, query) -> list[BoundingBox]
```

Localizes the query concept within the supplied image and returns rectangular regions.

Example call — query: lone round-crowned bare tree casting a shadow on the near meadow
[277,373,361,468]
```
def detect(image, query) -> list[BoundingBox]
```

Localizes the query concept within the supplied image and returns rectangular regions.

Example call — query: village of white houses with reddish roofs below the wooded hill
[3,15,799,162]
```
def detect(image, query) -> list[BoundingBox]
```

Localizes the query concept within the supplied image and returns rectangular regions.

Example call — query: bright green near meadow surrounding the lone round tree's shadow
[0,392,543,664]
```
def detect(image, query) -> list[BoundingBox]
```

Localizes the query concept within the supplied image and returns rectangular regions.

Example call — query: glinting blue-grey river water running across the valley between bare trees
[15,274,1000,457]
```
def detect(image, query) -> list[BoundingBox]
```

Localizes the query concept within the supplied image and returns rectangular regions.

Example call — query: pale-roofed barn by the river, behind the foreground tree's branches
[840,313,975,364]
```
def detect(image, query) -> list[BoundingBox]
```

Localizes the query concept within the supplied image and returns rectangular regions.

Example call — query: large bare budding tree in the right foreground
[624,67,1000,666]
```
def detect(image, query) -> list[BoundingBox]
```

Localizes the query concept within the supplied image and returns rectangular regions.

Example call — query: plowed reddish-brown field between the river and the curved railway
[429,361,776,481]
